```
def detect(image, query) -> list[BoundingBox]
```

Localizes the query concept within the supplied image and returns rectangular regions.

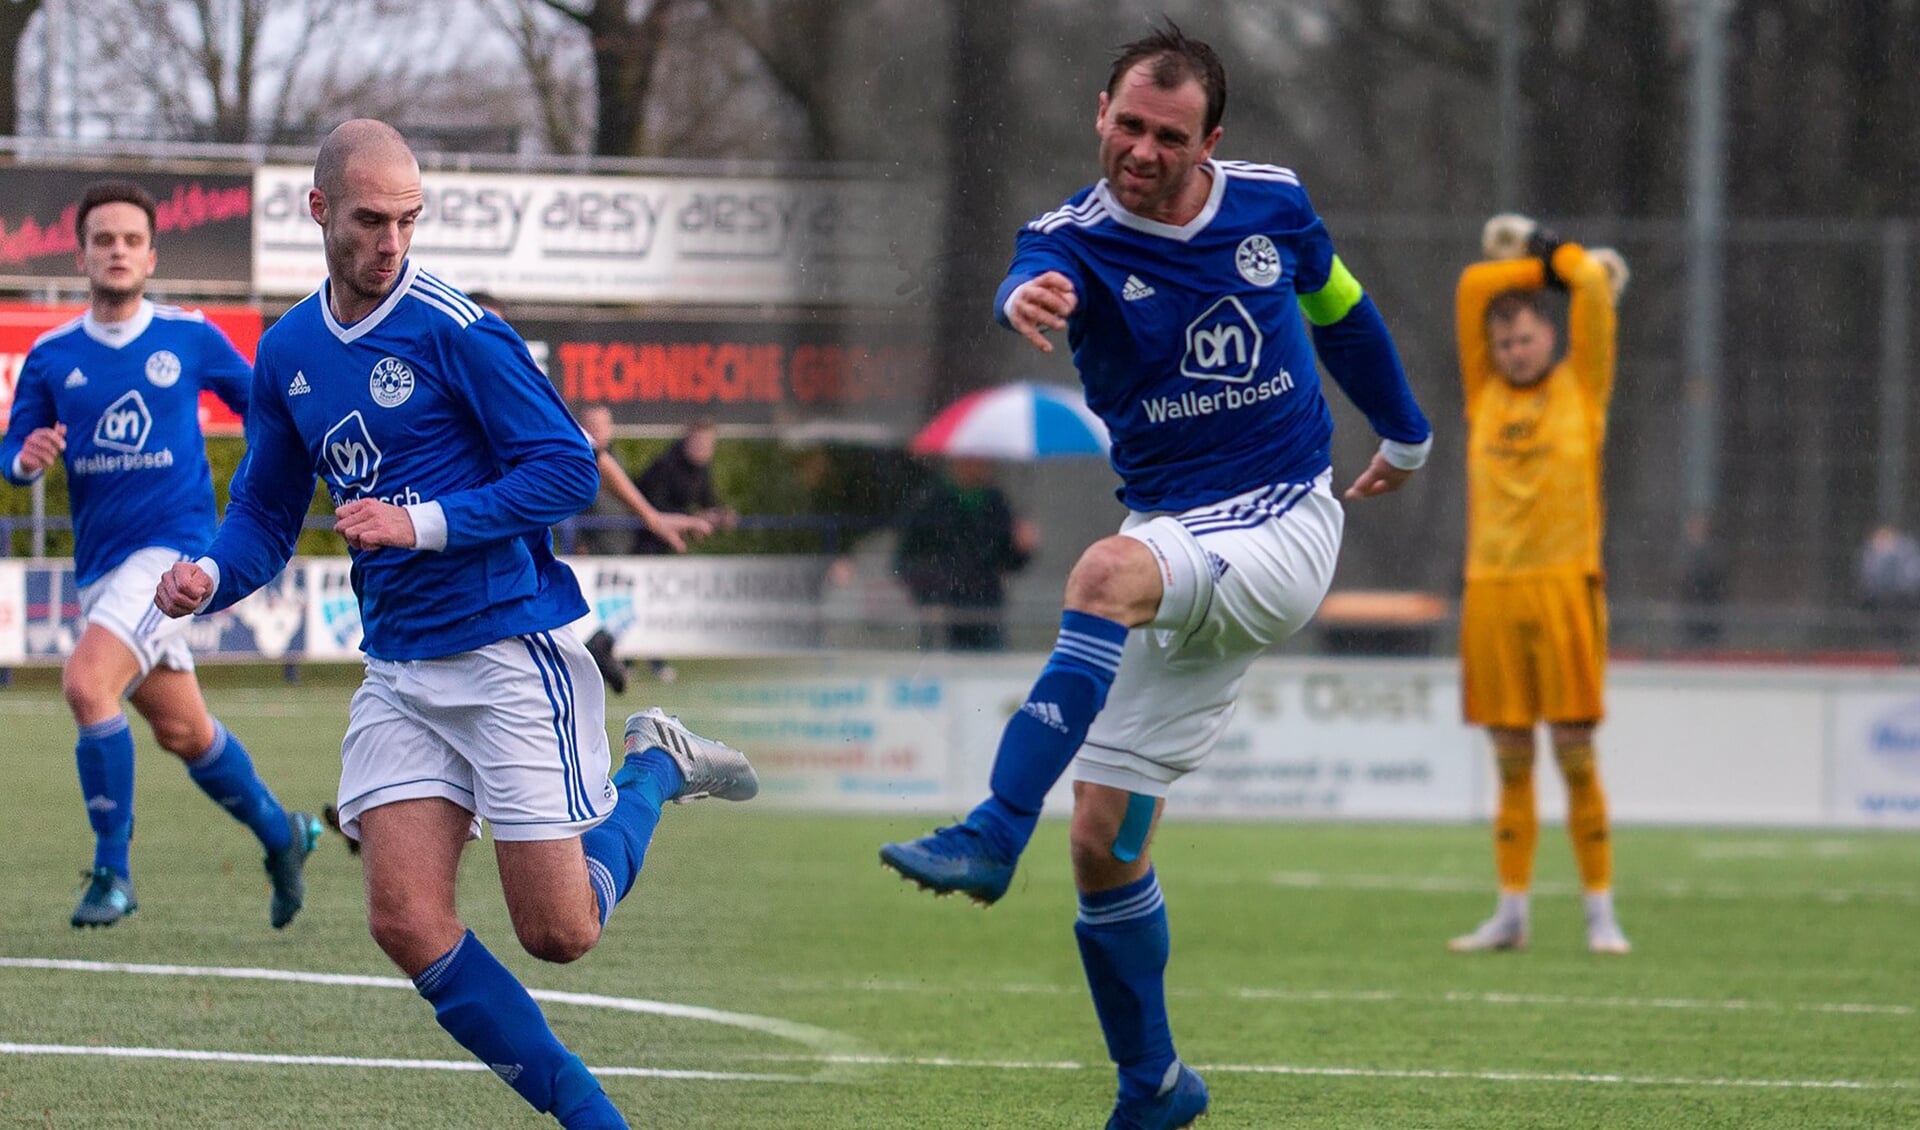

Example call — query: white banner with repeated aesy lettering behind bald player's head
[253,165,929,305]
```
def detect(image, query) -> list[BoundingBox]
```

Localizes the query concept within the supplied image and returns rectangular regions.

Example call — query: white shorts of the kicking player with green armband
[1073,472,1346,796]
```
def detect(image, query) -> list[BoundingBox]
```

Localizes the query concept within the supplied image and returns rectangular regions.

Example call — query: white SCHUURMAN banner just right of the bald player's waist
[566,554,831,658]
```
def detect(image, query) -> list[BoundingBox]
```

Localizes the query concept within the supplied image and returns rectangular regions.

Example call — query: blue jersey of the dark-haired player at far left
[0,301,253,585]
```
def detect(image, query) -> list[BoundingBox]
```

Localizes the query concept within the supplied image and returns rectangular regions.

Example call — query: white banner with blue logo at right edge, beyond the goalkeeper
[1828,689,1920,827]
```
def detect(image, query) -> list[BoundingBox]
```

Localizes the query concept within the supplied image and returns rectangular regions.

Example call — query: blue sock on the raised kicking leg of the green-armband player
[968,610,1127,861]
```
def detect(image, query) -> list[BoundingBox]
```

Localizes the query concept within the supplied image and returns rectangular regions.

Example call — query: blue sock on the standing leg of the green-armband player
[1073,871,1175,1101]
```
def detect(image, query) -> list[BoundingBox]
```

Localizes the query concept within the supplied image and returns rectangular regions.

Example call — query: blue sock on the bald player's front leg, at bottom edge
[413,930,626,1128]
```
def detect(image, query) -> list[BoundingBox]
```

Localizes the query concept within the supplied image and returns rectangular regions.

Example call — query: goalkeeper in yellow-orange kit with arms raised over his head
[1450,215,1630,953]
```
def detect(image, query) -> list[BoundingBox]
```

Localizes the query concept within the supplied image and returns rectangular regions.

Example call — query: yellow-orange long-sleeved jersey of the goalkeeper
[1453,244,1615,581]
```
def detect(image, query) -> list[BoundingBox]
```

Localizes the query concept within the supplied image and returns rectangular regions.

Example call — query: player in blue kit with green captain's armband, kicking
[881,23,1432,1130]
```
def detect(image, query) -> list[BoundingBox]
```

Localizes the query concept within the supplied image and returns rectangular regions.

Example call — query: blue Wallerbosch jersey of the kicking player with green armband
[995,161,1432,510]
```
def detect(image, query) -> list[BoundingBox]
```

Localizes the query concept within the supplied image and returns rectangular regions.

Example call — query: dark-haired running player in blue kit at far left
[0,180,321,929]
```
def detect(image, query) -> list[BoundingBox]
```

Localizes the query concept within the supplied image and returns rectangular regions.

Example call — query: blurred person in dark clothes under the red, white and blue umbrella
[893,459,1041,650]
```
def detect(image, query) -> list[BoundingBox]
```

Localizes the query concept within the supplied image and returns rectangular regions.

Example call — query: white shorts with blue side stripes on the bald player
[340,629,616,840]
